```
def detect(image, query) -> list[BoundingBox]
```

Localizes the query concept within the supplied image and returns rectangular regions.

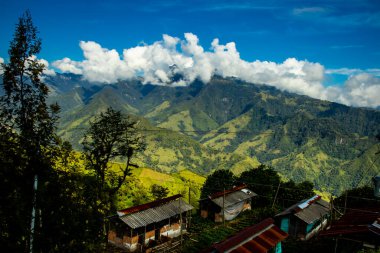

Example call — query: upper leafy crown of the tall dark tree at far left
[1,11,59,150]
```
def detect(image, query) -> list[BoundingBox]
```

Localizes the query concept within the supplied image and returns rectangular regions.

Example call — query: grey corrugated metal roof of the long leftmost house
[120,199,194,229]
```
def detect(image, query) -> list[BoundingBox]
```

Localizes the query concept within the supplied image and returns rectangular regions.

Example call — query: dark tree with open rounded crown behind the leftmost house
[83,108,145,241]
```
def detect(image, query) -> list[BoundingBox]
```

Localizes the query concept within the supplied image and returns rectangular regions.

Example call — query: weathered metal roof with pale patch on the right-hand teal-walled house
[276,197,330,224]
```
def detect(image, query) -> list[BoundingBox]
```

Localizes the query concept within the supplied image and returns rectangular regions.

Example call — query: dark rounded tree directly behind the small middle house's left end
[201,170,236,199]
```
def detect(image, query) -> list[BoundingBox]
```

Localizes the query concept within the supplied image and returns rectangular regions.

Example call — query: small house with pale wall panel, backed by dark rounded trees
[199,185,257,222]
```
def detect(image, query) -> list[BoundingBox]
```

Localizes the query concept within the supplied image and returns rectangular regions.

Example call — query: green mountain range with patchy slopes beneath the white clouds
[45,74,380,194]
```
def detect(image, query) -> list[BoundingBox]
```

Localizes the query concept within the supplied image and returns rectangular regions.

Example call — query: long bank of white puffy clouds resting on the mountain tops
[53,33,380,107]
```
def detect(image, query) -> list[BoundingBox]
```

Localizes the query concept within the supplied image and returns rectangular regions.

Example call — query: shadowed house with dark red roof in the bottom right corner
[319,208,380,252]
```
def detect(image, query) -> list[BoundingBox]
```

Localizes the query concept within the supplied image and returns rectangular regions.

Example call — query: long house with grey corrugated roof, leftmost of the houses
[108,194,193,252]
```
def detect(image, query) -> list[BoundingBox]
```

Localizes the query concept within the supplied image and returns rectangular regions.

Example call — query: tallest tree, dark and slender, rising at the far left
[1,11,59,251]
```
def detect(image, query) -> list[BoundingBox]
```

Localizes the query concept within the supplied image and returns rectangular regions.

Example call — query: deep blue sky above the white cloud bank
[0,0,380,107]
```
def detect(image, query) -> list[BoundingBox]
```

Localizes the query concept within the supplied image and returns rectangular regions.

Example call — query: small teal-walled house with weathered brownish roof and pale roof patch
[275,195,331,240]
